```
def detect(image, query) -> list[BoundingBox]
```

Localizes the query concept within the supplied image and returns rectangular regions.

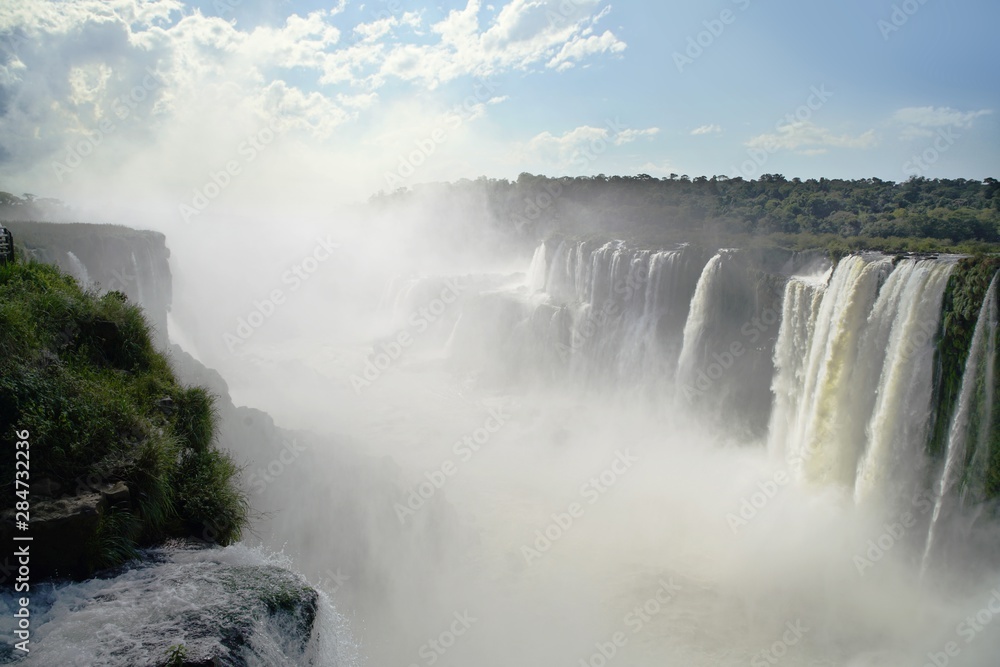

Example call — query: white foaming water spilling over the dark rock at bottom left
[0,545,361,667]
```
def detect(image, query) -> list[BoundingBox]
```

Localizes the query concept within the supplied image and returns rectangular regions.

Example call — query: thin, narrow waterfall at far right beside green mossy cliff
[922,275,997,572]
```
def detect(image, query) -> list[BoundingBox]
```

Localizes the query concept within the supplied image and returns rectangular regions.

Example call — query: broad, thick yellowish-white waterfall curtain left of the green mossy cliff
[768,255,954,504]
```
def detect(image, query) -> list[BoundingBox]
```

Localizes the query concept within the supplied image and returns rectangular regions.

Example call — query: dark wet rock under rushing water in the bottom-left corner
[0,545,344,667]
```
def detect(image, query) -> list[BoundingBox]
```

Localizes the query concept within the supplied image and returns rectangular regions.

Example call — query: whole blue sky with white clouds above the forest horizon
[0,0,1000,222]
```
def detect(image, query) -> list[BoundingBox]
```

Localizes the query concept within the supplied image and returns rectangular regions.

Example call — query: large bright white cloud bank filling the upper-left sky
[0,0,626,210]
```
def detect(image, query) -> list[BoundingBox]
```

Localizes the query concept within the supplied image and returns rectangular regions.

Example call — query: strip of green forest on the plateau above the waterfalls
[372,174,1000,256]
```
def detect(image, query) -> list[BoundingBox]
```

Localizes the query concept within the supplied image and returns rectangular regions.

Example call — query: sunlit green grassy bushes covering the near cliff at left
[0,261,249,566]
